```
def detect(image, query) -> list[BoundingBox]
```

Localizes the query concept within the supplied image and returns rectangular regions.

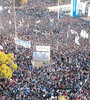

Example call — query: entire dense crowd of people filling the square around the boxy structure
[0,0,90,100]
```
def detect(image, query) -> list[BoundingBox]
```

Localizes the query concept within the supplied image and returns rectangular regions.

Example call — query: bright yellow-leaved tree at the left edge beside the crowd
[0,52,17,79]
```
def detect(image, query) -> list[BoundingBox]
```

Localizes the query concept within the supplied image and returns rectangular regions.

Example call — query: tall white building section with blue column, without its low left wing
[71,0,90,17]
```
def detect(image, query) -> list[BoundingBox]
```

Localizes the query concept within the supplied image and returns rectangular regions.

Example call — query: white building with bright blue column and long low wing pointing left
[48,0,90,17]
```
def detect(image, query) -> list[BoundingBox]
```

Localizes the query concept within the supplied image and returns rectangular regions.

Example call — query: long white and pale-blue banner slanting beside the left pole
[14,38,31,48]
